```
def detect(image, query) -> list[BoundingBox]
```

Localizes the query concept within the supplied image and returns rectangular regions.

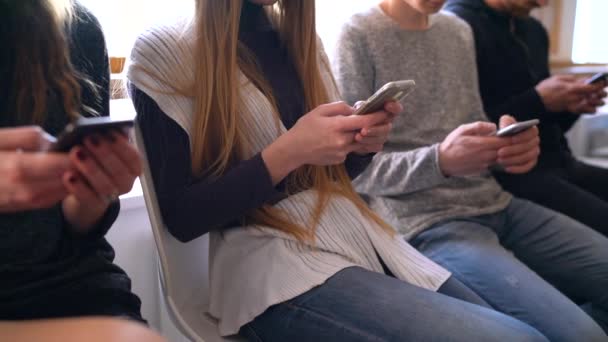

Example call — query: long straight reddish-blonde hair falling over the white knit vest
[184,0,393,240]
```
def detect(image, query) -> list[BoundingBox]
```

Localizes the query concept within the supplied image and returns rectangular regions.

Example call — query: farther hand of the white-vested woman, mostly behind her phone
[353,102,403,155]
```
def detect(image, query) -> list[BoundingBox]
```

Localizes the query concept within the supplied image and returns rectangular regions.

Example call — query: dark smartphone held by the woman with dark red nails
[50,117,133,152]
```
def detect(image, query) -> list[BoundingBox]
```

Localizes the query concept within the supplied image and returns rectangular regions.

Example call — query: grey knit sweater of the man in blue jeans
[333,7,511,238]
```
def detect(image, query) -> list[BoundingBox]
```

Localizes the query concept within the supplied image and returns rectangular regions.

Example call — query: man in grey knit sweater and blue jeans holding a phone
[333,0,608,341]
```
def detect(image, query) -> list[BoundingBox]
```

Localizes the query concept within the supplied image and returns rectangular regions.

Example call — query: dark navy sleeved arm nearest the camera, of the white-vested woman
[131,87,290,241]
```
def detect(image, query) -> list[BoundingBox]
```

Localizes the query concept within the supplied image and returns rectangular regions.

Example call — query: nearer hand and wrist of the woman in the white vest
[262,102,389,184]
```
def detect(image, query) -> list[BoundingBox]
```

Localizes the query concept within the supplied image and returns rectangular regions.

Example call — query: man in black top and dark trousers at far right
[446,0,608,235]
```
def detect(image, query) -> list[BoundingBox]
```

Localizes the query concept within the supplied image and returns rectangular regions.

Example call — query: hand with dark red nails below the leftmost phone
[63,132,141,232]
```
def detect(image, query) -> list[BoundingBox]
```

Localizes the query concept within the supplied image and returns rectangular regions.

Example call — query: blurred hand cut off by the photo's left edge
[0,126,70,213]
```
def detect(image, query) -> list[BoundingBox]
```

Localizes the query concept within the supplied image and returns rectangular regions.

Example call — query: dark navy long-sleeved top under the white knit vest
[130,1,371,241]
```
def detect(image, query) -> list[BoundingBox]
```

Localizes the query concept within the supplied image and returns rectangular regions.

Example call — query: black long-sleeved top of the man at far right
[446,0,578,165]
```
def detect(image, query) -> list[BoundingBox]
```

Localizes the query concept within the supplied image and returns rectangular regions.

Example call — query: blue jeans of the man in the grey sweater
[410,199,608,341]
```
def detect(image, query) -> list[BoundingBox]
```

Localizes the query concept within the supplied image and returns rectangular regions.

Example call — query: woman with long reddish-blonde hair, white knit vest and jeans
[129,0,544,341]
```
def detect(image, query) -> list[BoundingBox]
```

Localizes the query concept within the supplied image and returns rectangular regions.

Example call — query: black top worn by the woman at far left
[0,6,141,320]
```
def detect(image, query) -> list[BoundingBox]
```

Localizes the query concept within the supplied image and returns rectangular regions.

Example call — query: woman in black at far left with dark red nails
[0,0,143,322]
